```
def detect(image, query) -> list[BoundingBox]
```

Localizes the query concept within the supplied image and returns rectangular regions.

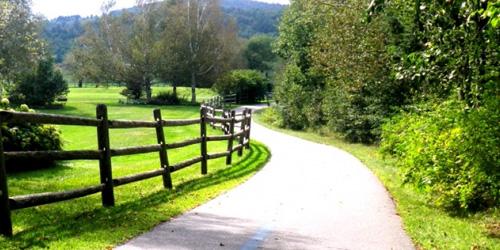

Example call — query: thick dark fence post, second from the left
[96,104,115,206]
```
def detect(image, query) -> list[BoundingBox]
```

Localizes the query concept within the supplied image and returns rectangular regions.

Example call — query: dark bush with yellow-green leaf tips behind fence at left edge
[1,100,63,172]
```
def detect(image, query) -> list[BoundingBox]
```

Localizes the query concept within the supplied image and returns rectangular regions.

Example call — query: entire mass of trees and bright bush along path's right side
[275,0,500,213]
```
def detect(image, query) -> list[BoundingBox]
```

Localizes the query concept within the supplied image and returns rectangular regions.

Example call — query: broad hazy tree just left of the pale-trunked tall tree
[70,1,160,102]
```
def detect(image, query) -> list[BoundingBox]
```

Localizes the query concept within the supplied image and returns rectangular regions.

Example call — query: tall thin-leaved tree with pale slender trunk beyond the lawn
[159,0,239,103]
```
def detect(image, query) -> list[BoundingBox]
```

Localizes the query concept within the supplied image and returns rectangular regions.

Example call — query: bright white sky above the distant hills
[32,0,289,19]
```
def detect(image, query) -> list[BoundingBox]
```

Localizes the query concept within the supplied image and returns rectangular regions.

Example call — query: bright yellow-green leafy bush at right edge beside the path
[381,98,500,211]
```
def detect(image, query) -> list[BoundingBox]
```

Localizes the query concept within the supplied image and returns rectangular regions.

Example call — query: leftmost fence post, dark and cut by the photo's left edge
[0,126,12,237]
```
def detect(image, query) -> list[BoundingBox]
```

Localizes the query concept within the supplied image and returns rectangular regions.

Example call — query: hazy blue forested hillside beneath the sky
[42,0,286,63]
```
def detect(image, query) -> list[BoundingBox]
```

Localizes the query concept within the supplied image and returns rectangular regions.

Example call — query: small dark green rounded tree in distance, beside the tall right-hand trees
[243,35,277,72]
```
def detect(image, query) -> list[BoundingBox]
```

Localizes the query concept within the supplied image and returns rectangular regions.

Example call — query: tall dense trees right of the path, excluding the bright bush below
[275,0,500,143]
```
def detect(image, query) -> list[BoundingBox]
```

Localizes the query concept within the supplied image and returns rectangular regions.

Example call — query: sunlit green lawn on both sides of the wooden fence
[0,88,270,249]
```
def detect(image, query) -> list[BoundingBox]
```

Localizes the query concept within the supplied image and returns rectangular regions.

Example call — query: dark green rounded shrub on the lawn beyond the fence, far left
[9,59,68,106]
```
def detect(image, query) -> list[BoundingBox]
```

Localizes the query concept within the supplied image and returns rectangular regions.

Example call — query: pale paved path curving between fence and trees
[118,106,414,250]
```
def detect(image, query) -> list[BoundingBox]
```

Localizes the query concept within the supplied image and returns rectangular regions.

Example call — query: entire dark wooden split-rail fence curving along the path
[0,105,252,236]
